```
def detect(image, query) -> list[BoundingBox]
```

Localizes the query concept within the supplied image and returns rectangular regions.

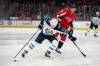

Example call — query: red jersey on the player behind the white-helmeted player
[56,8,76,29]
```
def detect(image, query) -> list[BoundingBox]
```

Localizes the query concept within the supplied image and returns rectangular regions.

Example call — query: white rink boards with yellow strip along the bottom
[0,20,100,30]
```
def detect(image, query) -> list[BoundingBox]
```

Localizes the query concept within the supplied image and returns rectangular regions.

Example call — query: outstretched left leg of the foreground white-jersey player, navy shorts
[22,33,45,57]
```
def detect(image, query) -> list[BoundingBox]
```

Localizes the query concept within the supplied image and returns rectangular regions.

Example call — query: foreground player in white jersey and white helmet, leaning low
[22,16,65,57]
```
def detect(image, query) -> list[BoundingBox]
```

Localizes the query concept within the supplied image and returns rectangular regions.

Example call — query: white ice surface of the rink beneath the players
[0,28,100,66]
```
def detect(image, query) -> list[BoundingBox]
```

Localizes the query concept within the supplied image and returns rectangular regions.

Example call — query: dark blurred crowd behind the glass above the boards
[0,0,100,21]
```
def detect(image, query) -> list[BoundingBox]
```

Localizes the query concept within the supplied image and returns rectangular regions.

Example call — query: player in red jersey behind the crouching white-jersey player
[46,6,76,55]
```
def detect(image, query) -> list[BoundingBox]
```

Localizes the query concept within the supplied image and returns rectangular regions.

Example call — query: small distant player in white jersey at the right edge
[85,12,100,37]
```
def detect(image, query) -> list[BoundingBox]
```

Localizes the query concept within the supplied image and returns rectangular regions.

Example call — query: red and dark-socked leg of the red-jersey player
[55,34,67,54]
